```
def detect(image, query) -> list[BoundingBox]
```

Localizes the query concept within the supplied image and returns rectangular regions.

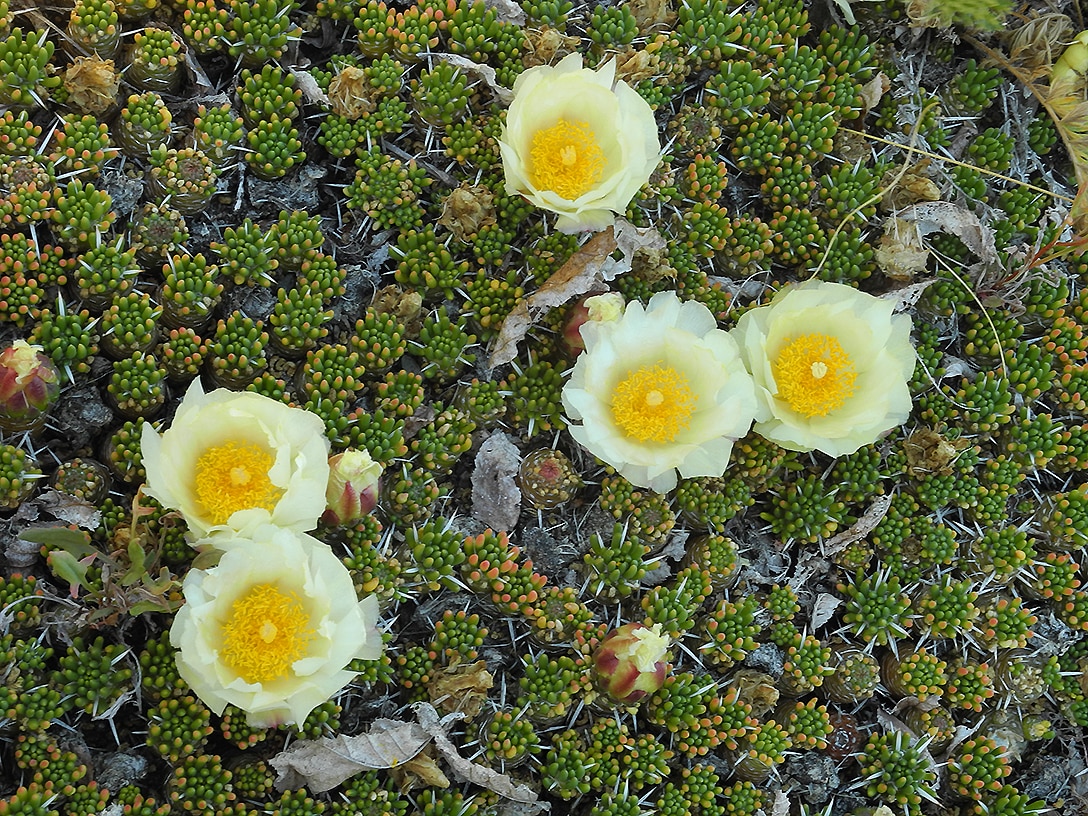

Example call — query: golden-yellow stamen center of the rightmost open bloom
[774,334,856,417]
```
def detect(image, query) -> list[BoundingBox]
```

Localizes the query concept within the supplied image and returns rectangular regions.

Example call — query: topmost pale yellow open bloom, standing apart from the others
[498,53,660,233]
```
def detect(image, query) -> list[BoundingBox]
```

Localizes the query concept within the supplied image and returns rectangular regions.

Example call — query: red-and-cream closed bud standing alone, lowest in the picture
[592,623,669,705]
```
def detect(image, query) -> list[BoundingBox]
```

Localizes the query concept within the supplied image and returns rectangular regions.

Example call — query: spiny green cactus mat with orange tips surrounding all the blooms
[0,0,1088,816]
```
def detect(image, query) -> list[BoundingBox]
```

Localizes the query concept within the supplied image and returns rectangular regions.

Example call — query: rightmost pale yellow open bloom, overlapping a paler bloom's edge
[732,281,915,456]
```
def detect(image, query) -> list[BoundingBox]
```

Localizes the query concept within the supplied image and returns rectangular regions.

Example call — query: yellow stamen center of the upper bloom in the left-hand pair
[196,442,283,524]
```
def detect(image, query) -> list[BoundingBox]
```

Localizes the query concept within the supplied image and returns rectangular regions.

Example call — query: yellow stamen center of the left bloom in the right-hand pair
[613,363,695,442]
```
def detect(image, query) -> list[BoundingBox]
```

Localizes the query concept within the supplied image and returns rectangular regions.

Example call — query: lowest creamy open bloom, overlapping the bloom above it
[170,524,382,727]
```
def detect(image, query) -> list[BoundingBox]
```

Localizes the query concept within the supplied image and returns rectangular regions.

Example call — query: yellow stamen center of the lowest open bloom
[220,583,313,683]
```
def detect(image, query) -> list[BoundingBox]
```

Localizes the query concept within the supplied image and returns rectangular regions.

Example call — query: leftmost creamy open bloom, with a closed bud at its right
[140,380,329,536]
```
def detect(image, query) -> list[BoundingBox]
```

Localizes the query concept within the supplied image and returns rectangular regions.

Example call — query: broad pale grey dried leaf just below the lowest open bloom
[269,719,431,793]
